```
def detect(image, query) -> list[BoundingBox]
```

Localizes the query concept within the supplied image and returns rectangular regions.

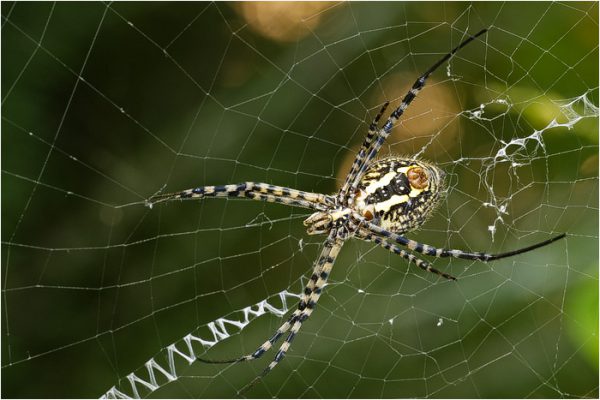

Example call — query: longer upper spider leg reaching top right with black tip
[340,29,487,204]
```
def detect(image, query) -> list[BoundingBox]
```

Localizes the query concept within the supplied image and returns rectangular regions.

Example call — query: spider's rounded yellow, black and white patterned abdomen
[355,156,445,233]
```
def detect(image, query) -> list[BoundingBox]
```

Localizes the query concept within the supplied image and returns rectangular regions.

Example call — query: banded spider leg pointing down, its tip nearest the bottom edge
[238,233,343,395]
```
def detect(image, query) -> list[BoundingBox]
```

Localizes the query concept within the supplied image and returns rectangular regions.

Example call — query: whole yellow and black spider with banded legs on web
[150,29,565,394]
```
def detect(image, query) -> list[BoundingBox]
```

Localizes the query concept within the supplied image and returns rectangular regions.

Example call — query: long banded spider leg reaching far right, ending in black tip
[362,221,567,261]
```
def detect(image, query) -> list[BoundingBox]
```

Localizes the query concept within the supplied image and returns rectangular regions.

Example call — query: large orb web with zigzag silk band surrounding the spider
[2,2,599,398]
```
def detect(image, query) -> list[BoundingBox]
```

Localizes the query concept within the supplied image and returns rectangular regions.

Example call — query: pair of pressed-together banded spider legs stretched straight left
[149,182,335,211]
